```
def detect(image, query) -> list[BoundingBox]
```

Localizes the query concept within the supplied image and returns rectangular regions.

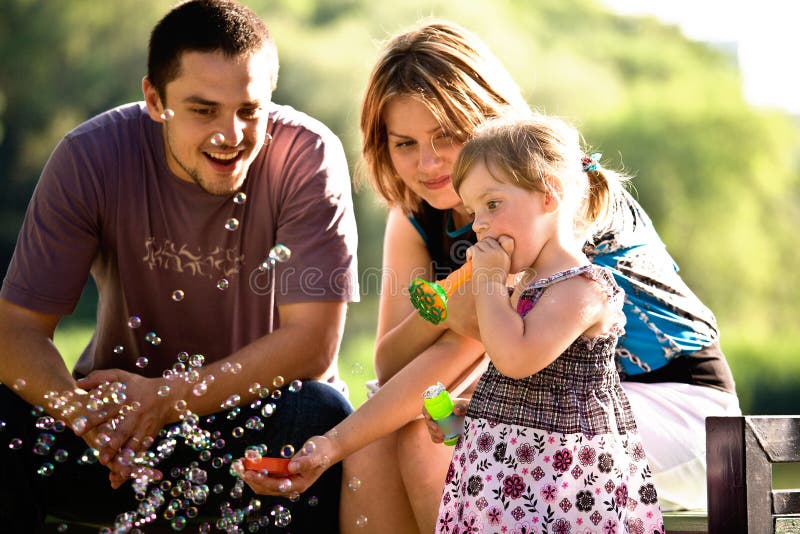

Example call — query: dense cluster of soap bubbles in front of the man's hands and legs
[5,316,317,534]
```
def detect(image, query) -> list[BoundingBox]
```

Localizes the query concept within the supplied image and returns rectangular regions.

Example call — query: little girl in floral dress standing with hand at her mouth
[429,116,663,533]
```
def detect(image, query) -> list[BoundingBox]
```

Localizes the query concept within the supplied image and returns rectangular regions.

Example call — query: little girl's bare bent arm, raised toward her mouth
[476,276,610,378]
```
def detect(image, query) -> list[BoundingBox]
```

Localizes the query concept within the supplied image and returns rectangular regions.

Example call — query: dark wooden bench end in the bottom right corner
[706,415,800,534]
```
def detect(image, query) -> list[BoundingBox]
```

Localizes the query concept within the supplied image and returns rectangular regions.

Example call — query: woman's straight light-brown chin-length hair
[357,20,530,213]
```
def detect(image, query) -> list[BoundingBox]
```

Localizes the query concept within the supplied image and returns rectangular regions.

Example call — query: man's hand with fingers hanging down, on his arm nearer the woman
[76,369,179,489]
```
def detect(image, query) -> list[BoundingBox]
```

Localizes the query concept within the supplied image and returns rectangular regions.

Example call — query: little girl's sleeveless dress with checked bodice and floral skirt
[436,265,664,534]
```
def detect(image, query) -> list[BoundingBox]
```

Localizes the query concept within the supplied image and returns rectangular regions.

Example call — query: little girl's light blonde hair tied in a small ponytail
[451,114,628,239]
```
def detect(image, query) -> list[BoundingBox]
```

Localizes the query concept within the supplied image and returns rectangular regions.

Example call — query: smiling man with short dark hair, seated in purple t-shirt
[0,0,358,532]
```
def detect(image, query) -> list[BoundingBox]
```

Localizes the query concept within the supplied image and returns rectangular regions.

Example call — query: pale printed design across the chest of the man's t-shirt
[142,237,244,278]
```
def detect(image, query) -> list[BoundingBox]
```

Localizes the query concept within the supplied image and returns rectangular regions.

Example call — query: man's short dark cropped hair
[147,0,278,101]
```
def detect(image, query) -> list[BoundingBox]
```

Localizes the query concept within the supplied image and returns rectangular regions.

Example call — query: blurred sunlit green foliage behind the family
[0,0,800,413]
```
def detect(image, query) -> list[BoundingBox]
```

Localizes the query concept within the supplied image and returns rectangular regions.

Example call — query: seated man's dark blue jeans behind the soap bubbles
[0,381,352,534]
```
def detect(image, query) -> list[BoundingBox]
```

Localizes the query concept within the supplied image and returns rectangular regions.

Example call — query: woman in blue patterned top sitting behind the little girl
[245,21,739,532]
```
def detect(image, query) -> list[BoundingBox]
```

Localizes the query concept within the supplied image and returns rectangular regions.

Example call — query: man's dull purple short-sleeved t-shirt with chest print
[0,103,359,382]
